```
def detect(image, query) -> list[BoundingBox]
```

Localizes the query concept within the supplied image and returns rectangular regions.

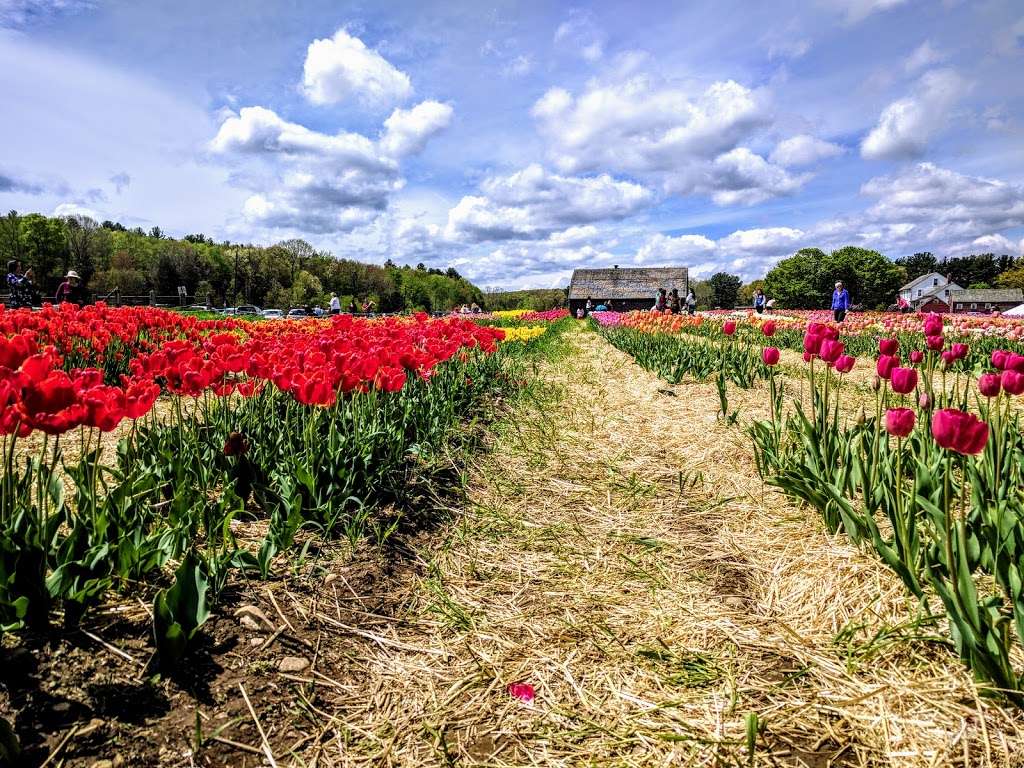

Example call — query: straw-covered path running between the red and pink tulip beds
[307,327,1024,767]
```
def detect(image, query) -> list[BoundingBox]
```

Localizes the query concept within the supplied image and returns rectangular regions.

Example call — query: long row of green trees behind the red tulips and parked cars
[0,211,485,311]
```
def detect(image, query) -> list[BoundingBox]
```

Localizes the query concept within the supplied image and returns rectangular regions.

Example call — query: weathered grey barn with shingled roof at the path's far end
[569,264,690,317]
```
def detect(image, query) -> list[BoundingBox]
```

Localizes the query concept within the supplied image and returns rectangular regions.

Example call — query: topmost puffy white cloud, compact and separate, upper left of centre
[302,29,413,108]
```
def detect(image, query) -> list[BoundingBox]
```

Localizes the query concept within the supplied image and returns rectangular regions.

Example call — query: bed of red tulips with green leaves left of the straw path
[0,304,573,763]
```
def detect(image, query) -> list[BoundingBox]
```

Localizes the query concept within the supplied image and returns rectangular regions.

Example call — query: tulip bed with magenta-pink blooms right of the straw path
[594,312,1024,706]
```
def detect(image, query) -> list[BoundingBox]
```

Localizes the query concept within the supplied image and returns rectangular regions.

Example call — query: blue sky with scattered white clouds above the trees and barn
[0,0,1024,288]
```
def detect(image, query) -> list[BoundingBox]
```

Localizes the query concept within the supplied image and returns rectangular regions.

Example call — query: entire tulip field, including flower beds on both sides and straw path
[6,304,1024,768]
